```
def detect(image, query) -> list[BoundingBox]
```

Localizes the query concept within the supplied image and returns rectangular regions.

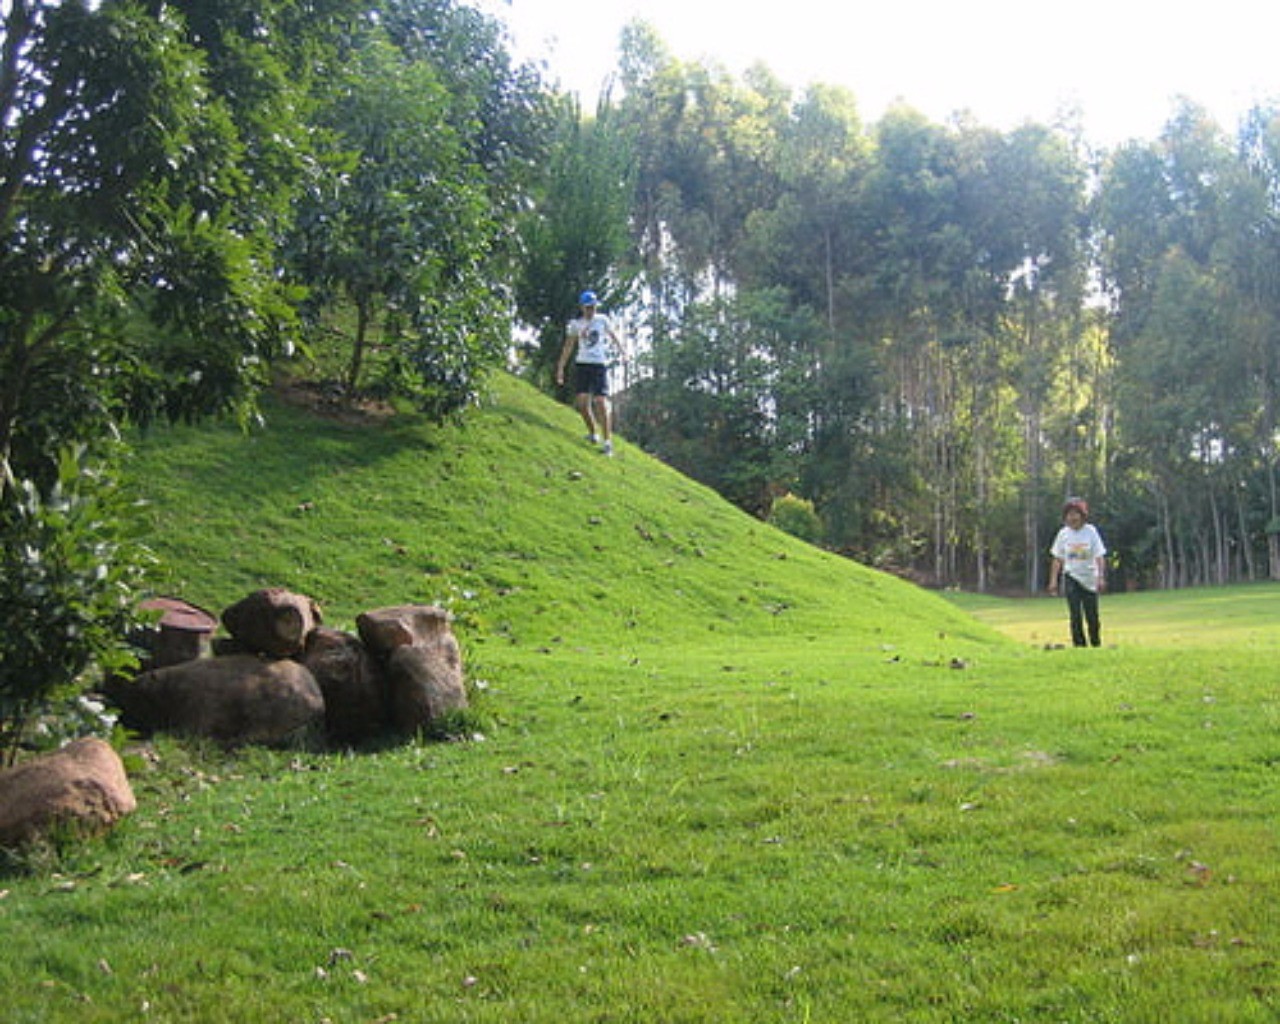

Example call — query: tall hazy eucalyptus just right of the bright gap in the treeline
[1101,104,1260,586]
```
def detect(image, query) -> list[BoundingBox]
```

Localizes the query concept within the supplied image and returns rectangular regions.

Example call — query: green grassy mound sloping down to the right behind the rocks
[133,378,997,653]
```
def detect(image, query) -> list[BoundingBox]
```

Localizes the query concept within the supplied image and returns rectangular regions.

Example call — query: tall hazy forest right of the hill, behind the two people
[532,26,1280,591]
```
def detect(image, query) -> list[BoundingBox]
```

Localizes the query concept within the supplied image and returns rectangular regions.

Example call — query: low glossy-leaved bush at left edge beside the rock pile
[0,449,145,760]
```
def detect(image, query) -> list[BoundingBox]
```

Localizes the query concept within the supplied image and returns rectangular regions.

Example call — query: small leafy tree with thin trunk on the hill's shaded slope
[294,33,507,415]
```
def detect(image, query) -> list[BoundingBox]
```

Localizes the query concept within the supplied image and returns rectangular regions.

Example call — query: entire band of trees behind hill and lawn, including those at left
[0,0,1280,616]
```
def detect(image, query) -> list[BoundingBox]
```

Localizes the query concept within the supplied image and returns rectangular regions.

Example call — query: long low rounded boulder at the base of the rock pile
[106,654,324,744]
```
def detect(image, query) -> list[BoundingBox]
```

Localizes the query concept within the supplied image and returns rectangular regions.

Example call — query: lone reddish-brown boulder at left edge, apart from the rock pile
[0,737,137,847]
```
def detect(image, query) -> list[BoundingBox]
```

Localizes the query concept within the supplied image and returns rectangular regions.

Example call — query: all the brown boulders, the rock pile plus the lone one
[0,588,467,846]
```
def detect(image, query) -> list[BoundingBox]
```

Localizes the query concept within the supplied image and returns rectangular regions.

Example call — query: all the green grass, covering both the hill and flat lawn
[0,381,1280,1021]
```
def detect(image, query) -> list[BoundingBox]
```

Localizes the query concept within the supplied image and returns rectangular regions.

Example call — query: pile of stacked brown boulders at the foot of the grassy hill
[106,588,467,744]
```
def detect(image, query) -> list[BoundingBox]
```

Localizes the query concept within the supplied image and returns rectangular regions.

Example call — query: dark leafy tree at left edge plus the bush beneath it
[0,0,340,758]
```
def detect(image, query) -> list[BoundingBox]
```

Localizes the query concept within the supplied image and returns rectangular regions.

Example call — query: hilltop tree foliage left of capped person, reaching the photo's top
[288,3,552,419]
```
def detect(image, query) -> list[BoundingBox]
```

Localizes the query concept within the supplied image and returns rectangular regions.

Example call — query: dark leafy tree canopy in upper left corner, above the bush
[0,0,322,488]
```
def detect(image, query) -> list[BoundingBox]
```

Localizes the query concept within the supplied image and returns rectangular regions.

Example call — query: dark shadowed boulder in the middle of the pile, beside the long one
[301,626,387,742]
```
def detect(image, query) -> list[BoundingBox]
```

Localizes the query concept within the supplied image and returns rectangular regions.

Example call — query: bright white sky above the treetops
[475,0,1280,146]
